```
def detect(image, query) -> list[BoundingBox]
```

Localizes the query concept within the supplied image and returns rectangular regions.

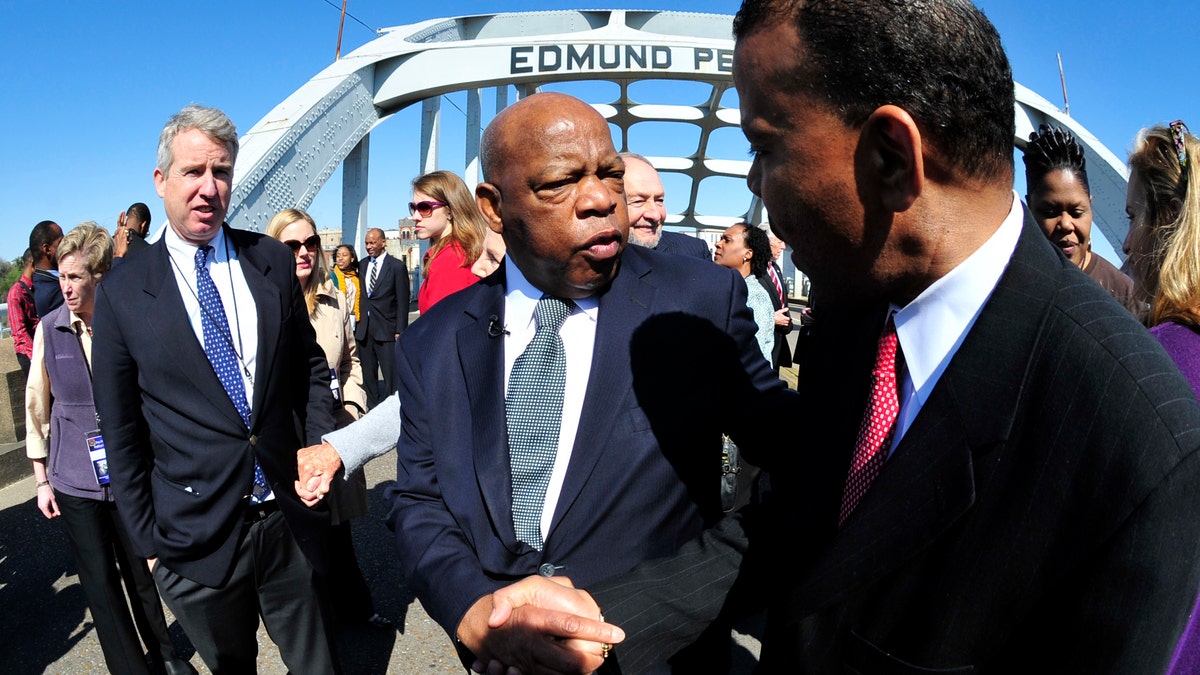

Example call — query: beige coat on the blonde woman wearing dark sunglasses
[308,281,367,525]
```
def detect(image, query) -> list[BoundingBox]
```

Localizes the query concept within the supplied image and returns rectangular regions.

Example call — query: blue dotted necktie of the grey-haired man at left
[196,246,271,503]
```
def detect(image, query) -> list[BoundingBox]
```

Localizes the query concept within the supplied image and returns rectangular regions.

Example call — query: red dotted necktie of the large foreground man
[838,316,900,525]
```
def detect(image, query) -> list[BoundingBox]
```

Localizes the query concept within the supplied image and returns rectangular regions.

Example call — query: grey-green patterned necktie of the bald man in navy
[504,295,575,550]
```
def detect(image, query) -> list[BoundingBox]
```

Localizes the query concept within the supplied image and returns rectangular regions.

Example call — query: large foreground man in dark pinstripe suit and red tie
[480,0,1200,674]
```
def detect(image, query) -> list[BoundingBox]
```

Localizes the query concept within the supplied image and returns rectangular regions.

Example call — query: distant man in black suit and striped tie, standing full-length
[354,227,409,407]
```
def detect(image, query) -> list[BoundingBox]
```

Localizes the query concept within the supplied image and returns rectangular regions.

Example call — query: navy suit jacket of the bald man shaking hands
[388,246,794,635]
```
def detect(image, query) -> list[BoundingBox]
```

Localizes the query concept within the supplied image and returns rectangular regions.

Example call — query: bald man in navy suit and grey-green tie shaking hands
[389,94,792,657]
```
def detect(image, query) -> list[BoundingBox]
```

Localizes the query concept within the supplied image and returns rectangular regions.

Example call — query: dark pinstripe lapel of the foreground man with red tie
[793,213,1055,615]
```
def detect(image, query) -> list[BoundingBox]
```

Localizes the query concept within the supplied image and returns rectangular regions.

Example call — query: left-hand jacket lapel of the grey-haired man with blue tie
[139,239,245,426]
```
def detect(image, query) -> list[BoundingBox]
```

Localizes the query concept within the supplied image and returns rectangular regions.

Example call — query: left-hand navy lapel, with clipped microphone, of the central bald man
[457,265,517,538]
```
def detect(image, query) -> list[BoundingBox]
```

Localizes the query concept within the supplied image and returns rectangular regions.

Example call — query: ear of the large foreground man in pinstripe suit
[859,106,925,213]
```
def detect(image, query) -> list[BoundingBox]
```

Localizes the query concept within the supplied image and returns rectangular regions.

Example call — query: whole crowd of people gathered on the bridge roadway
[8,0,1200,675]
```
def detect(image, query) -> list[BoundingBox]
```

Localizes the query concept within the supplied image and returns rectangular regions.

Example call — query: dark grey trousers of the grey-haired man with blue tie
[154,510,335,675]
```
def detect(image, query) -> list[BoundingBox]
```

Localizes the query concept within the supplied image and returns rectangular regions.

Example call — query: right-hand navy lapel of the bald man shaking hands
[548,253,655,536]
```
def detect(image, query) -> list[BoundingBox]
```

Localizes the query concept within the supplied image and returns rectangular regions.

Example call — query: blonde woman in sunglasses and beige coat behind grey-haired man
[266,209,391,628]
